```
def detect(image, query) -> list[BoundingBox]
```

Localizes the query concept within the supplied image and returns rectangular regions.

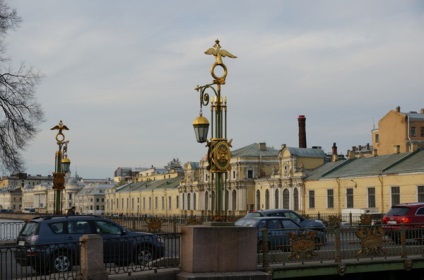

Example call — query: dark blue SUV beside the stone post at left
[15,215,165,273]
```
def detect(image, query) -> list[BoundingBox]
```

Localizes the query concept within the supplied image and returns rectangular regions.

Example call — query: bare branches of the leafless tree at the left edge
[0,0,44,172]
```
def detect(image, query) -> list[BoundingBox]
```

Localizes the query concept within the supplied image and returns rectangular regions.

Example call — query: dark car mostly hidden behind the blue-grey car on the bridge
[244,209,325,231]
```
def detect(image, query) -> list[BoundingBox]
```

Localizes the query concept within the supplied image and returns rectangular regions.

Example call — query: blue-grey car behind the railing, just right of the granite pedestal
[234,217,327,252]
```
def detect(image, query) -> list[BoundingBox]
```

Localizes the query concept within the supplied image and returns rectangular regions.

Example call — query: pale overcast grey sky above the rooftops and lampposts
[4,0,424,178]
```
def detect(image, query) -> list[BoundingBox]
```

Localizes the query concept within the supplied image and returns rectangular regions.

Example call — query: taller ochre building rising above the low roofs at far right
[372,107,424,155]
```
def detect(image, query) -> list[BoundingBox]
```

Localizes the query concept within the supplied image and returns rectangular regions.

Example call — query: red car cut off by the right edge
[381,202,424,244]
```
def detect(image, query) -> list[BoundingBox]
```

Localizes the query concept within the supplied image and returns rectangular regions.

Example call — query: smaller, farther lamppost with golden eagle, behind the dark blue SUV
[51,121,71,215]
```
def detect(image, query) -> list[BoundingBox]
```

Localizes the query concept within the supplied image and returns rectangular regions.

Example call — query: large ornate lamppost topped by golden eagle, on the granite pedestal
[193,40,237,221]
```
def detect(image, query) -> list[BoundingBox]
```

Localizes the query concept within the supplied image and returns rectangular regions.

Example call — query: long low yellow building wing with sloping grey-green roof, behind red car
[304,148,424,218]
